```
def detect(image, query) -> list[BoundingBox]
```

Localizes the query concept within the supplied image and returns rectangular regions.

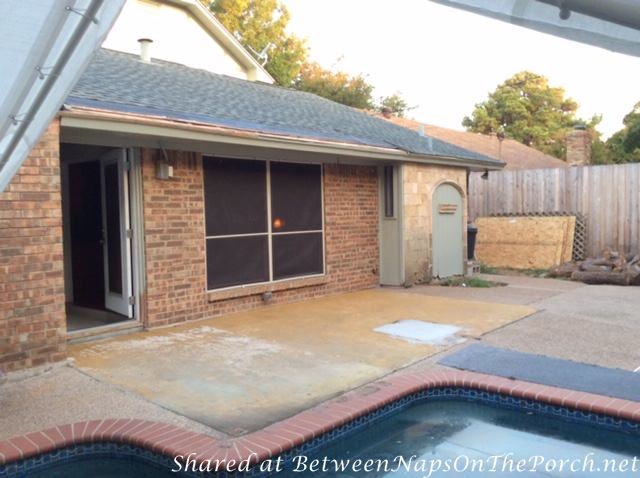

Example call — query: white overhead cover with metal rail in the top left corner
[0,0,125,191]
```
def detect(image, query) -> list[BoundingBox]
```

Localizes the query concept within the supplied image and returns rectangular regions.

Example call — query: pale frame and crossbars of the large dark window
[202,154,327,293]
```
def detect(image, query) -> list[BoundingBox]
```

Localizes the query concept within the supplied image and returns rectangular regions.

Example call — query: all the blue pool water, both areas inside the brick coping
[6,401,640,478]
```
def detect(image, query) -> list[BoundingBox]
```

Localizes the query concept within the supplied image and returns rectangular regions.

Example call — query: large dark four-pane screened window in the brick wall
[204,158,324,290]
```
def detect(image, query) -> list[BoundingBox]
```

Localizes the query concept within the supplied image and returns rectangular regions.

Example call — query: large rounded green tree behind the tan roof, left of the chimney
[462,71,600,159]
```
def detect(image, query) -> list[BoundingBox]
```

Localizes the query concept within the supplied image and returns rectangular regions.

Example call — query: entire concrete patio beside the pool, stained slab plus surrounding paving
[0,276,640,444]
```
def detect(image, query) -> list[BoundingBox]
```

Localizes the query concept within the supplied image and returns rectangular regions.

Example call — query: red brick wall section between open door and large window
[142,149,206,326]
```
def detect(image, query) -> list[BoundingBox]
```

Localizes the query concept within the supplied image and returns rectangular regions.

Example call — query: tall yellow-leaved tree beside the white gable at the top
[209,0,307,86]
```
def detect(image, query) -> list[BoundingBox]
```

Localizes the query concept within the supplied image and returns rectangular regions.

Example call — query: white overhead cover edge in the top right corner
[431,0,640,56]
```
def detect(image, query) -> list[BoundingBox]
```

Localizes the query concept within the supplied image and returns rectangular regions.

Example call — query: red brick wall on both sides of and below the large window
[143,150,379,327]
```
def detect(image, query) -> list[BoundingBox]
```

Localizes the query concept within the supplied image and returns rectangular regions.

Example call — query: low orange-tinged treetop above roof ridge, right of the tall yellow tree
[293,63,374,109]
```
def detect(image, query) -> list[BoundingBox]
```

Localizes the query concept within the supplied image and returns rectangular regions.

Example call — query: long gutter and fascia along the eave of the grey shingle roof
[60,106,504,171]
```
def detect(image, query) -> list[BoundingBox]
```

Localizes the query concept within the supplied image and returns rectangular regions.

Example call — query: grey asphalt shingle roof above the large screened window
[65,49,501,164]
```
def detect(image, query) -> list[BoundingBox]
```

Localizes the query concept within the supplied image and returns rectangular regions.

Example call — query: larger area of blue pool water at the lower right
[286,401,640,477]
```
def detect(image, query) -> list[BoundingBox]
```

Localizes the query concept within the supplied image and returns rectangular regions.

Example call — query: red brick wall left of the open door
[0,120,66,372]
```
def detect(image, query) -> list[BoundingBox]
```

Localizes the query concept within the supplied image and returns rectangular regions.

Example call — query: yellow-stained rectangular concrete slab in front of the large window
[69,289,535,435]
